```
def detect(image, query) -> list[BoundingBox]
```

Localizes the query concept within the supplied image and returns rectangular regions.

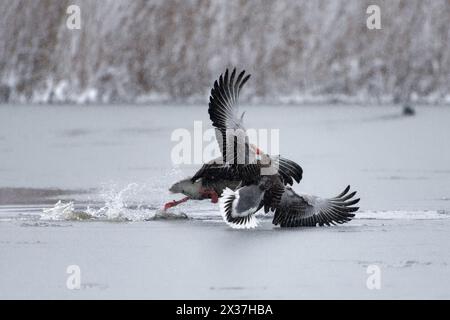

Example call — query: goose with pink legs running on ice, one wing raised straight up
[163,68,303,211]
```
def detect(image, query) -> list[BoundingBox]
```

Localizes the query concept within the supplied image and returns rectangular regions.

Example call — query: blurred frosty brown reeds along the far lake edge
[0,0,450,104]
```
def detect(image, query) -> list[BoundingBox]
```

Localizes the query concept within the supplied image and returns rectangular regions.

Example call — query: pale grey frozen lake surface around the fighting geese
[0,106,450,299]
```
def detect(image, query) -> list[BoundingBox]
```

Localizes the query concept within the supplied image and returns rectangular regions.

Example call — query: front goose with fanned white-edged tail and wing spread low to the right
[219,176,360,229]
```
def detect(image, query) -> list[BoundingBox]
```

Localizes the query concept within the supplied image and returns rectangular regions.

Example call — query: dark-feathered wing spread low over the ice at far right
[272,186,359,227]
